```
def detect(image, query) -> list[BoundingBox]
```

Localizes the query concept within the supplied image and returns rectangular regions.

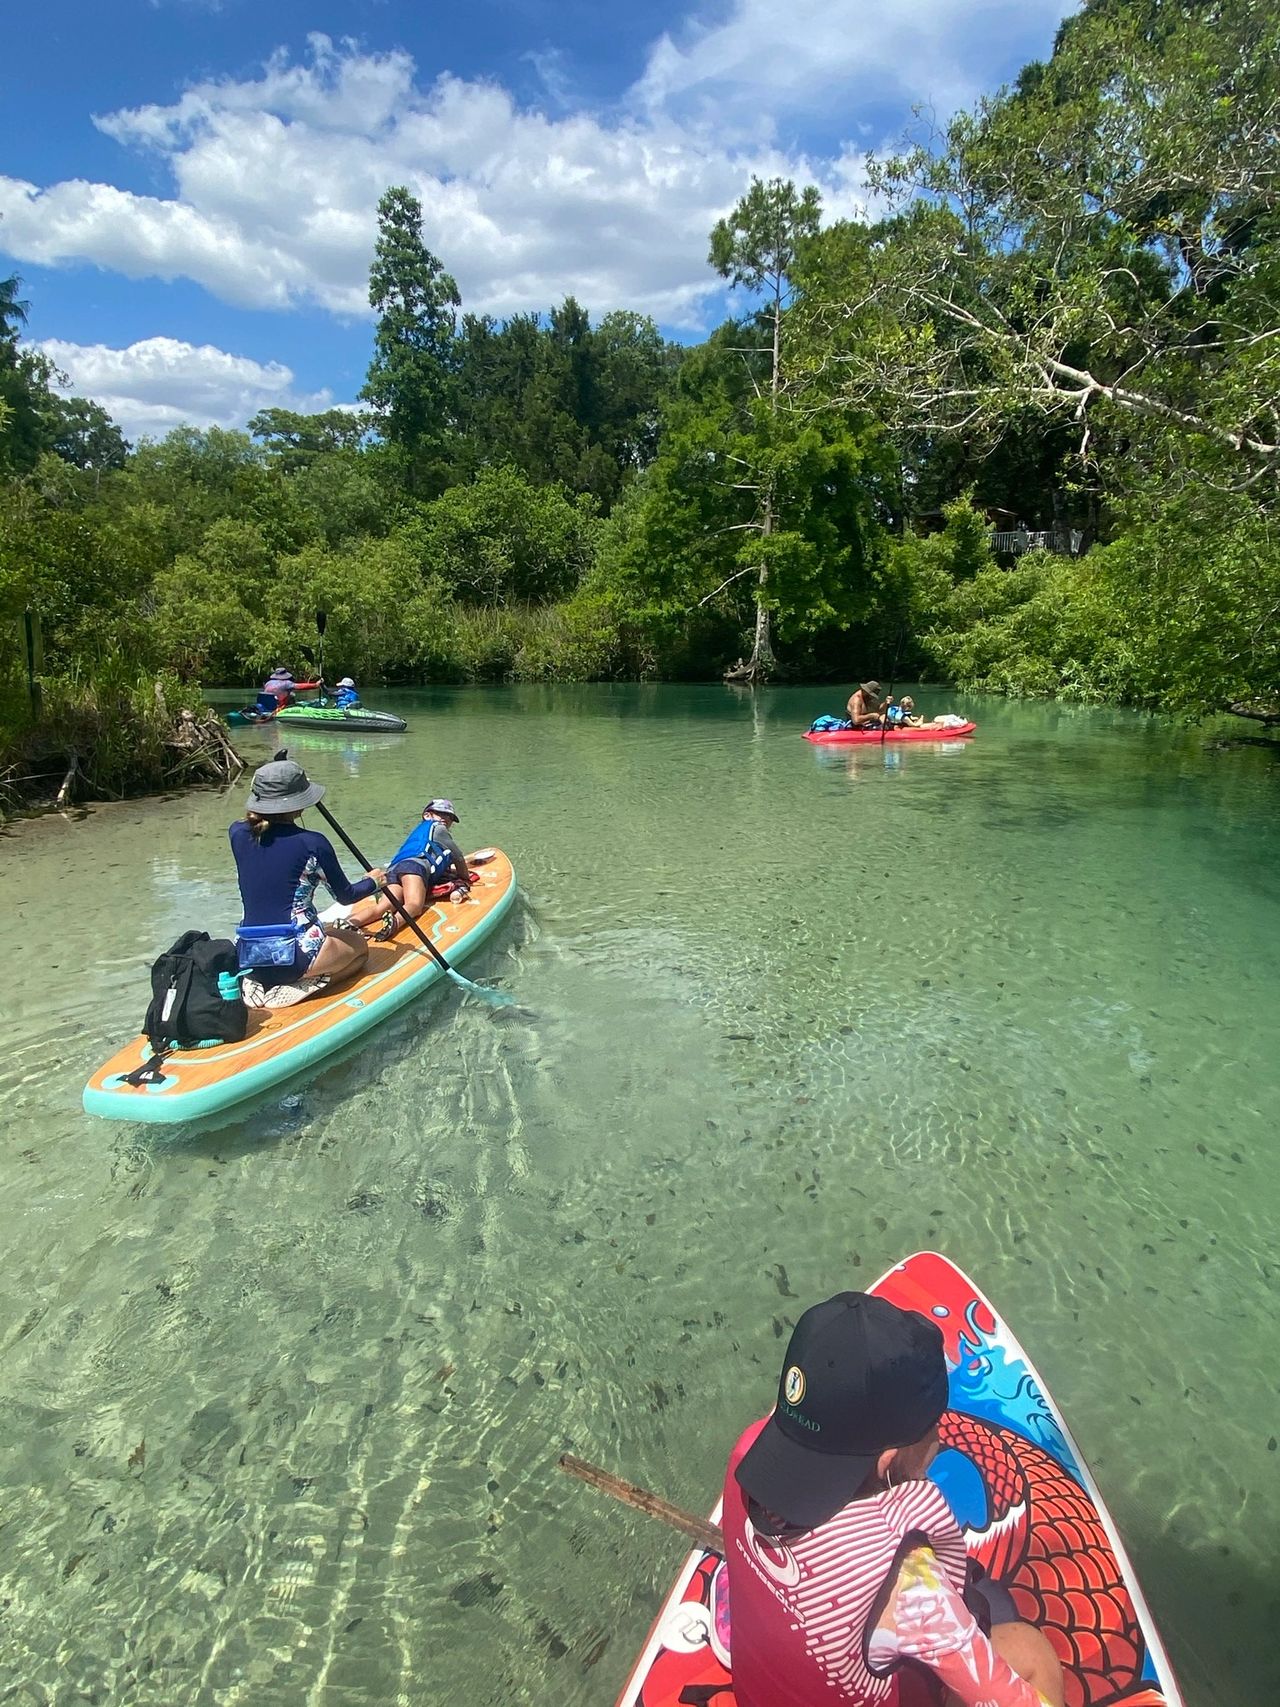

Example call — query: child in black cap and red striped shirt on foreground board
[722,1292,1063,1707]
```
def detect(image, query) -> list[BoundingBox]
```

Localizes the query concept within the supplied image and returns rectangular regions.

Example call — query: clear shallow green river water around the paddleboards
[0,688,1280,1707]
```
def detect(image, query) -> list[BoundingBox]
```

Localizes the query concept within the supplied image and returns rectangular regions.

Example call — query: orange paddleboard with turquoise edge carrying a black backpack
[84,850,515,1121]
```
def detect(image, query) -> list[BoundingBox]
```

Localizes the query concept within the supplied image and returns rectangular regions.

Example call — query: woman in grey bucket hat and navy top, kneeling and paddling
[230,753,386,988]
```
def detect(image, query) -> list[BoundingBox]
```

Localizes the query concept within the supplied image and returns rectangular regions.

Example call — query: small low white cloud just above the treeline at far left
[38,338,333,439]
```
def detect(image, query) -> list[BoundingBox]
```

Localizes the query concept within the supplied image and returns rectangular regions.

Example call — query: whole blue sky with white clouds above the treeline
[0,0,1068,437]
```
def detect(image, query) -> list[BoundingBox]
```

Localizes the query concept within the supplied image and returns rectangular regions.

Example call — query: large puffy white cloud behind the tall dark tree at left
[0,38,855,328]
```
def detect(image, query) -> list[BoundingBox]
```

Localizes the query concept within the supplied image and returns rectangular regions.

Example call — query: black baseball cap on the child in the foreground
[736,1292,947,1529]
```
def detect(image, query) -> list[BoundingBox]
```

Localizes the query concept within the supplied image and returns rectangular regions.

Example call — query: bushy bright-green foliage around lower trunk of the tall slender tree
[584,323,893,676]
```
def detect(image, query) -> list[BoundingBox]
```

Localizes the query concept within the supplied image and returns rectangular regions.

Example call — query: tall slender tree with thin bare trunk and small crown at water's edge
[710,178,821,683]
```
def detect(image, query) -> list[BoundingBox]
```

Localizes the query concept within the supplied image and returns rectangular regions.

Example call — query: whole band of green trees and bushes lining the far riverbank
[0,0,1280,787]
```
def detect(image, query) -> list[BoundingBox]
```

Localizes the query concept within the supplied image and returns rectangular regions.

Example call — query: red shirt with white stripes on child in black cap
[722,1419,966,1707]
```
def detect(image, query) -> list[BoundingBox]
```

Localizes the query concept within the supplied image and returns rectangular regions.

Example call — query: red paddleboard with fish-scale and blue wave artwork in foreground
[618,1251,1183,1707]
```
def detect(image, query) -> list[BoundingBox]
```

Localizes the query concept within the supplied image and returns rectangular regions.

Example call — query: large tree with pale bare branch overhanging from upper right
[806,0,1280,483]
